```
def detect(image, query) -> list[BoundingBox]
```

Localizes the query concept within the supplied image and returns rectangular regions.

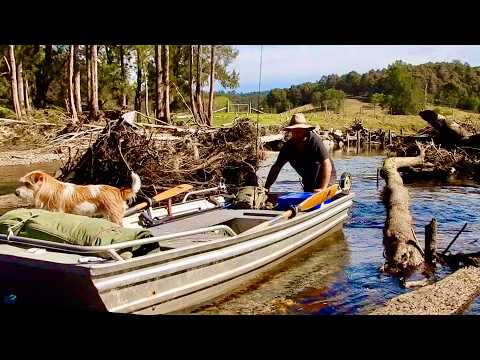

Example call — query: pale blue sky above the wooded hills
[219,45,480,92]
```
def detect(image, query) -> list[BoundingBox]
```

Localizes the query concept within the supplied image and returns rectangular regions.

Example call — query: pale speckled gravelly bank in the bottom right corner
[369,267,480,315]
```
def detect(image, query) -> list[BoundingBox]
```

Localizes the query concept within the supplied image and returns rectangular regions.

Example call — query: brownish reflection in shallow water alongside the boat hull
[196,228,350,314]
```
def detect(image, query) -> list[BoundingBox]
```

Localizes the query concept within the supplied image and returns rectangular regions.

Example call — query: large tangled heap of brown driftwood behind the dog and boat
[60,119,263,197]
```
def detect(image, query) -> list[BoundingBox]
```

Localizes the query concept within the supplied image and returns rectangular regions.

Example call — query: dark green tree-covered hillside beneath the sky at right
[263,61,480,112]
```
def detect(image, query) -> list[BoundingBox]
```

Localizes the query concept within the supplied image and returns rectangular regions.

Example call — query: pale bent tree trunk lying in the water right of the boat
[380,144,425,273]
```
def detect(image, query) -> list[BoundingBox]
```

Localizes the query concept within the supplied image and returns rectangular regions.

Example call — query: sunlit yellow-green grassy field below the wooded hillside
[214,99,480,134]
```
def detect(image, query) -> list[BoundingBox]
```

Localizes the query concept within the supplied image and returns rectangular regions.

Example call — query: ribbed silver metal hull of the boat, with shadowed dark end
[0,194,353,314]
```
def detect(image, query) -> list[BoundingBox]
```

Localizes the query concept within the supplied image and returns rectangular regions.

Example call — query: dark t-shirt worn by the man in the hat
[276,131,337,192]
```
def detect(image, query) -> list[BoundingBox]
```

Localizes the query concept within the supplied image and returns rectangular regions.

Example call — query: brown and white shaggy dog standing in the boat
[15,170,141,225]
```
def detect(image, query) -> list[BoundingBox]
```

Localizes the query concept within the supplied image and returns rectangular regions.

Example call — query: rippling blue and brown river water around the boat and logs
[0,152,480,315]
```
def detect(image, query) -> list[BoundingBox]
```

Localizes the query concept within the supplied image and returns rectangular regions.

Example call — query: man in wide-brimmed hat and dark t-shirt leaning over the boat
[265,114,337,192]
